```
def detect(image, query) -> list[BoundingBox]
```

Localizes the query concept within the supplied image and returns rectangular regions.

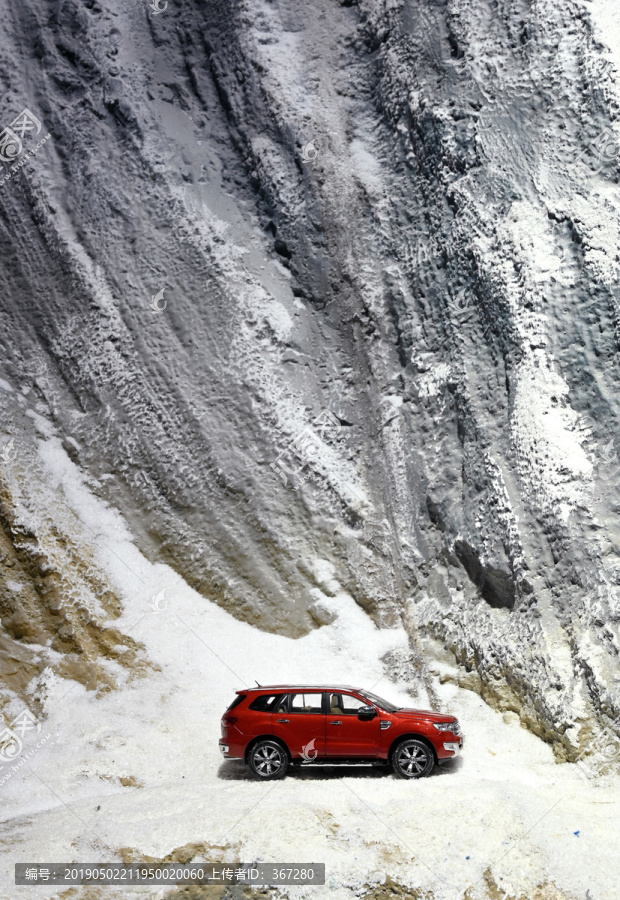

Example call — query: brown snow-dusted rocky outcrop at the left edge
[0,386,150,715]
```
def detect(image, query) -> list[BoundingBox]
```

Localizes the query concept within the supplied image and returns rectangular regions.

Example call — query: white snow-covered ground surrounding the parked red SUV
[0,434,620,900]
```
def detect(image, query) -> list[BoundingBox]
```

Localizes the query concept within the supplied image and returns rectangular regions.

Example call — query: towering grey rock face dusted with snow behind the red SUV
[0,0,620,758]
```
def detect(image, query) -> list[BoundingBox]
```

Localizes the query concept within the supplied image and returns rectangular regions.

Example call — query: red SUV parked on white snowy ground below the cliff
[220,685,463,781]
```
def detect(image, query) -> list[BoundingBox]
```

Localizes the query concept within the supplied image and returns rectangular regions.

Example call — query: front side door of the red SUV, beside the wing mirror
[325,691,381,759]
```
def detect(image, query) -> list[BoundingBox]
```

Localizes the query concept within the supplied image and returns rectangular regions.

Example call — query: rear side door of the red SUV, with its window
[272,691,325,762]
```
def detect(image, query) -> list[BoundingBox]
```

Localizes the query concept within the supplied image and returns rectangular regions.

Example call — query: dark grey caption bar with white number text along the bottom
[15,863,325,885]
